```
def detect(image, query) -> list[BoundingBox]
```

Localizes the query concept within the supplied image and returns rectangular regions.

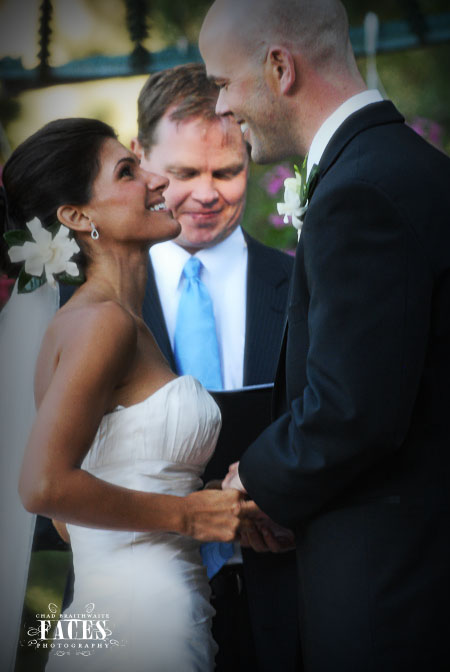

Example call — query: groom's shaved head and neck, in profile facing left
[199,0,365,162]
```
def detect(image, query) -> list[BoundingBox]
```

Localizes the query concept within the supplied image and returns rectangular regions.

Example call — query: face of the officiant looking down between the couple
[136,110,248,252]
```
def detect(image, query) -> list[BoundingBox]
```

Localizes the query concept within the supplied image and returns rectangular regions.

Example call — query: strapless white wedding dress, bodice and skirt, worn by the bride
[46,376,221,672]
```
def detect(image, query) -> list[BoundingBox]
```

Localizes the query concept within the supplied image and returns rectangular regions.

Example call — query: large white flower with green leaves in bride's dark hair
[3,217,84,294]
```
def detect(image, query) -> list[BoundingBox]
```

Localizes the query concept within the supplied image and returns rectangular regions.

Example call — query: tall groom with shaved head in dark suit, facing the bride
[200,0,450,672]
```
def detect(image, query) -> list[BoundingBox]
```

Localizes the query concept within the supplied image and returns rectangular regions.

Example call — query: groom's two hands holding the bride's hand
[206,462,295,553]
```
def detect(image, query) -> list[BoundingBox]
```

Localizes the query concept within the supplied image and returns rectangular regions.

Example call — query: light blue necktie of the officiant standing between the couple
[174,257,233,579]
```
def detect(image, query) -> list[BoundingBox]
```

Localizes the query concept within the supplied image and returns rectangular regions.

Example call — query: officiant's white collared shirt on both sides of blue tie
[150,226,248,390]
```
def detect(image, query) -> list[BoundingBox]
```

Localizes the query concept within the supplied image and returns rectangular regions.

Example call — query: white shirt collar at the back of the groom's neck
[306,89,383,178]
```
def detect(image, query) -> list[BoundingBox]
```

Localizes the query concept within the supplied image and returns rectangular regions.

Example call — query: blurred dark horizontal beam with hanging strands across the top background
[0,0,450,95]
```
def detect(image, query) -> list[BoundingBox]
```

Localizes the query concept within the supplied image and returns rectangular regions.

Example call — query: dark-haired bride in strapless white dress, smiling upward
[0,119,246,672]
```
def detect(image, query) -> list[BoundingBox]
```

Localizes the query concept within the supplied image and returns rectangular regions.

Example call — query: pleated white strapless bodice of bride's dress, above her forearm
[82,376,221,495]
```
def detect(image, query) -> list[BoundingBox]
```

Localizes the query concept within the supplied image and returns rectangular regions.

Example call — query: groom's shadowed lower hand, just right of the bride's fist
[239,500,295,553]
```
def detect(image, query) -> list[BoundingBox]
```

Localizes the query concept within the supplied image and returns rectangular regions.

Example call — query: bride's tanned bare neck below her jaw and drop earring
[85,250,148,317]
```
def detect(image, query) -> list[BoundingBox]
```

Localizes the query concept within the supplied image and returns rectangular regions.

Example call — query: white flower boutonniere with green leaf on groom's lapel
[277,156,319,240]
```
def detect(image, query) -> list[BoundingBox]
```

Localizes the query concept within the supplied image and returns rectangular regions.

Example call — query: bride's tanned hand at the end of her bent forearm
[182,490,244,541]
